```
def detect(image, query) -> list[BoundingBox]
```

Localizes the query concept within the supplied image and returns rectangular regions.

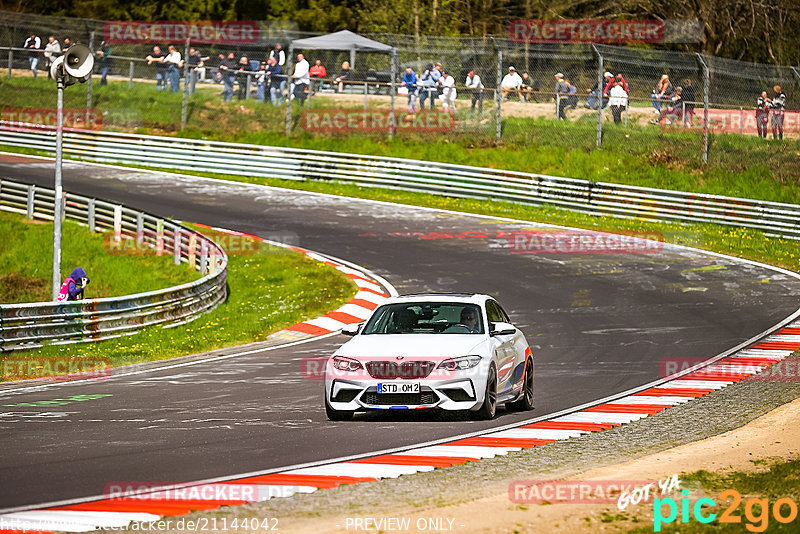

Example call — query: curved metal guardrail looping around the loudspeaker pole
[0,179,228,351]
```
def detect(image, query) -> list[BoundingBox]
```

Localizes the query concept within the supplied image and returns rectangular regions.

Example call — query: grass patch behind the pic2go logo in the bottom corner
[620,459,800,534]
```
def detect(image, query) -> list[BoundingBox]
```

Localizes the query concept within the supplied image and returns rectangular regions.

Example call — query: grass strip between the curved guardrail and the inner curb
[1,228,356,382]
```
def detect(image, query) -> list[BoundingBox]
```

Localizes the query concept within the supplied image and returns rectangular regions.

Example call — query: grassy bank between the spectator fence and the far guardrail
[0,79,800,203]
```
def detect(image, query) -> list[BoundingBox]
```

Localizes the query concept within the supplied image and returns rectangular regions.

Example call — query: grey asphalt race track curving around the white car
[0,157,800,509]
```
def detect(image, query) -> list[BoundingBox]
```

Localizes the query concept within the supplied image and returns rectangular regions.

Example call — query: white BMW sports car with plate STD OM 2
[325,294,533,421]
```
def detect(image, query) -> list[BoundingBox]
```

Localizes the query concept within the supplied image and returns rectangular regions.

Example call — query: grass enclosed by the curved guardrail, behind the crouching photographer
[0,212,199,304]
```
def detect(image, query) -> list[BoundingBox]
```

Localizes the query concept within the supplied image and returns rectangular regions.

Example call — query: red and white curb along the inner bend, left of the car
[197,224,397,340]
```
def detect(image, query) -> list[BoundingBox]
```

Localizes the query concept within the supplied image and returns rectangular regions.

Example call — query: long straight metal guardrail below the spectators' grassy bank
[0,125,800,238]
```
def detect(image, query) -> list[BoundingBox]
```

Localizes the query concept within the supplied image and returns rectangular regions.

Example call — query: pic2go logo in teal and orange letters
[653,490,797,532]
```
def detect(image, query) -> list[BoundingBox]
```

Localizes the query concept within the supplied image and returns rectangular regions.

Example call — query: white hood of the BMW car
[336,334,488,358]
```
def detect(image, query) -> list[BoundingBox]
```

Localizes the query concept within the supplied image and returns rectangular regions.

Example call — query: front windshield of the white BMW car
[363,302,484,334]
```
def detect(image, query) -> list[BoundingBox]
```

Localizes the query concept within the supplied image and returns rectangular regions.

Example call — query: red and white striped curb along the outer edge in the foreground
[0,320,800,533]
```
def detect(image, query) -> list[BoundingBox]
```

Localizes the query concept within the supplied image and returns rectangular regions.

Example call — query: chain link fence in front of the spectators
[0,11,800,172]
